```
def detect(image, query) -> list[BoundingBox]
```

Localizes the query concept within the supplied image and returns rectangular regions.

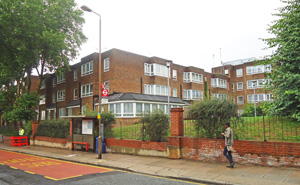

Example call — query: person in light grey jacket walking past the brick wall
[222,122,235,168]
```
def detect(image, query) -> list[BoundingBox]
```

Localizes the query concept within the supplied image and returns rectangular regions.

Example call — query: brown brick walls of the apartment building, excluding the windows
[35,49,272,119]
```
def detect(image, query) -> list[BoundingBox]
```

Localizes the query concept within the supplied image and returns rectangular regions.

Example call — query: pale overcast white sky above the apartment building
[73,0,284,72]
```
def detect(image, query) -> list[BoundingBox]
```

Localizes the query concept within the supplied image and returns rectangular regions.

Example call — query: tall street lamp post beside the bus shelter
[81,5,102,159]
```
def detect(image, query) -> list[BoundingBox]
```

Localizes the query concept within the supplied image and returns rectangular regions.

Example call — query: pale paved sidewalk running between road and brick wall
[0,143,300,185]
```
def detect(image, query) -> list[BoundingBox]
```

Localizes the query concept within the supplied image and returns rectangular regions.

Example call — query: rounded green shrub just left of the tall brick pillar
[141,110,169,142]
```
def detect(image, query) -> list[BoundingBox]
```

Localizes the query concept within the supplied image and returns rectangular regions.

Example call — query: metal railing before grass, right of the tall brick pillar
[184,115,300,142]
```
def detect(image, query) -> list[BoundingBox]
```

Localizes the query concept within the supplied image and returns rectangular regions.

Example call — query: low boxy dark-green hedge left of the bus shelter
[36,119,70,138]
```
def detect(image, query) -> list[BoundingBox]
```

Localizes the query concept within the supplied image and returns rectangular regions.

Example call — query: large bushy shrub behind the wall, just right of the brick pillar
[188,99,237,138]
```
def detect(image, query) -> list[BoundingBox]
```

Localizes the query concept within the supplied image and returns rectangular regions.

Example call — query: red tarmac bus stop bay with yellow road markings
[0,150,113,180]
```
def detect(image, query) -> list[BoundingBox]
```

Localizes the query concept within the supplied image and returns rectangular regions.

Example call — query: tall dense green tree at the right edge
[262,0,300,119]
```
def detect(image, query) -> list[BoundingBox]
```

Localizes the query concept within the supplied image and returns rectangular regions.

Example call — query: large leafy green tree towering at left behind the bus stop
[0,0,86,124]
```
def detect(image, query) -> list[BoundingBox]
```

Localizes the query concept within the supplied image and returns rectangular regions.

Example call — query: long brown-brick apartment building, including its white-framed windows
[38,49,271,120]
